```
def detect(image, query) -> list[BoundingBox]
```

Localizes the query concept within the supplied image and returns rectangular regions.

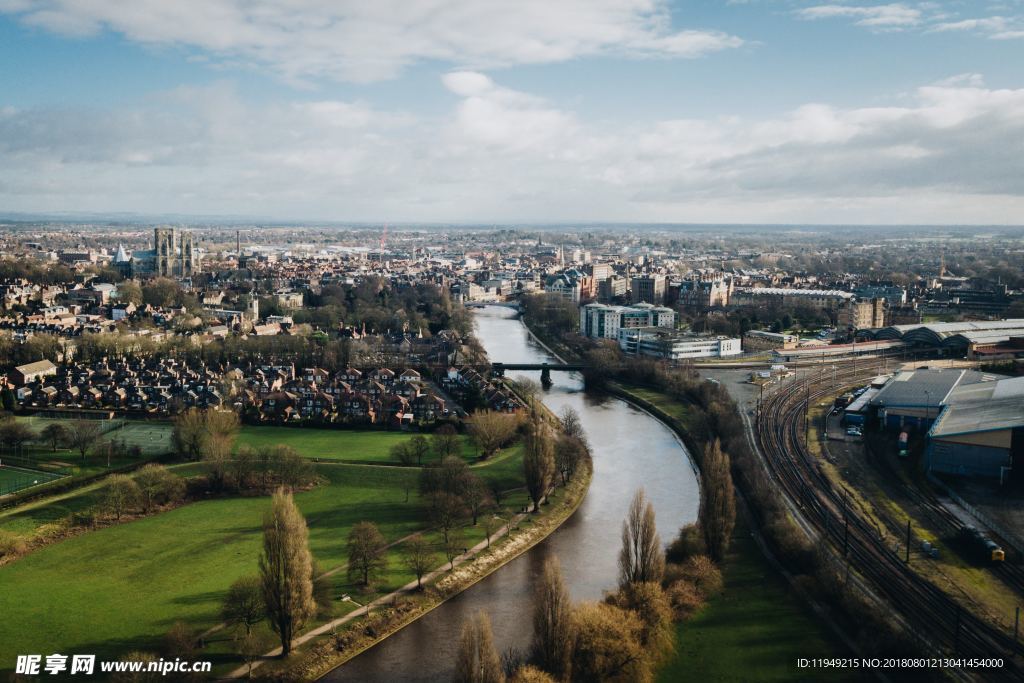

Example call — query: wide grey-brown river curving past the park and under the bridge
[323,306,699,682]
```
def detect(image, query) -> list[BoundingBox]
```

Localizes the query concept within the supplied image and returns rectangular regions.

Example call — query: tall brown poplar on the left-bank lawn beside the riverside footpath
[259,488,316,656]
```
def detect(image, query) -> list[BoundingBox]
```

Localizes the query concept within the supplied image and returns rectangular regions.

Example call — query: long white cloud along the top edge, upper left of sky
[0,0,743,82]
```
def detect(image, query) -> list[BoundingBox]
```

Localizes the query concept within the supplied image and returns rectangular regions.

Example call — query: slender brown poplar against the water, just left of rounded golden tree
[531,556,573,681]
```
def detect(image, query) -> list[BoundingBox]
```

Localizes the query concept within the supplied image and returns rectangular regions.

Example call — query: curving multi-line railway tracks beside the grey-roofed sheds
[756,364,1024,681]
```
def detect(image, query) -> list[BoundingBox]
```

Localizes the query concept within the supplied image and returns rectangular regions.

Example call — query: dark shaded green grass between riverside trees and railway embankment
[657,519,854,683]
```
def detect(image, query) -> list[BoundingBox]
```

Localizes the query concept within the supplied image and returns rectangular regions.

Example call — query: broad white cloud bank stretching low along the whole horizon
[0,72,1024,223]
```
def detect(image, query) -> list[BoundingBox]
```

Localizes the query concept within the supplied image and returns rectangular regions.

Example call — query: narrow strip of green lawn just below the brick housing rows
[238,425,477,465]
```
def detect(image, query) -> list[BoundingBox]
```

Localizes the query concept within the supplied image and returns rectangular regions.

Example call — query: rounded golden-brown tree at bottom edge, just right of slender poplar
[569,602,651,683]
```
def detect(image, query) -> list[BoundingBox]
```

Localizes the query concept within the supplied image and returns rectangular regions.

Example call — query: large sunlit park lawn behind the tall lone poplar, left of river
[0,466,424,670]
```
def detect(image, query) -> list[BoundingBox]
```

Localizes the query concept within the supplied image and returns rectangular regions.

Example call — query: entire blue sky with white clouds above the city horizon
[0,0,1024,224]
